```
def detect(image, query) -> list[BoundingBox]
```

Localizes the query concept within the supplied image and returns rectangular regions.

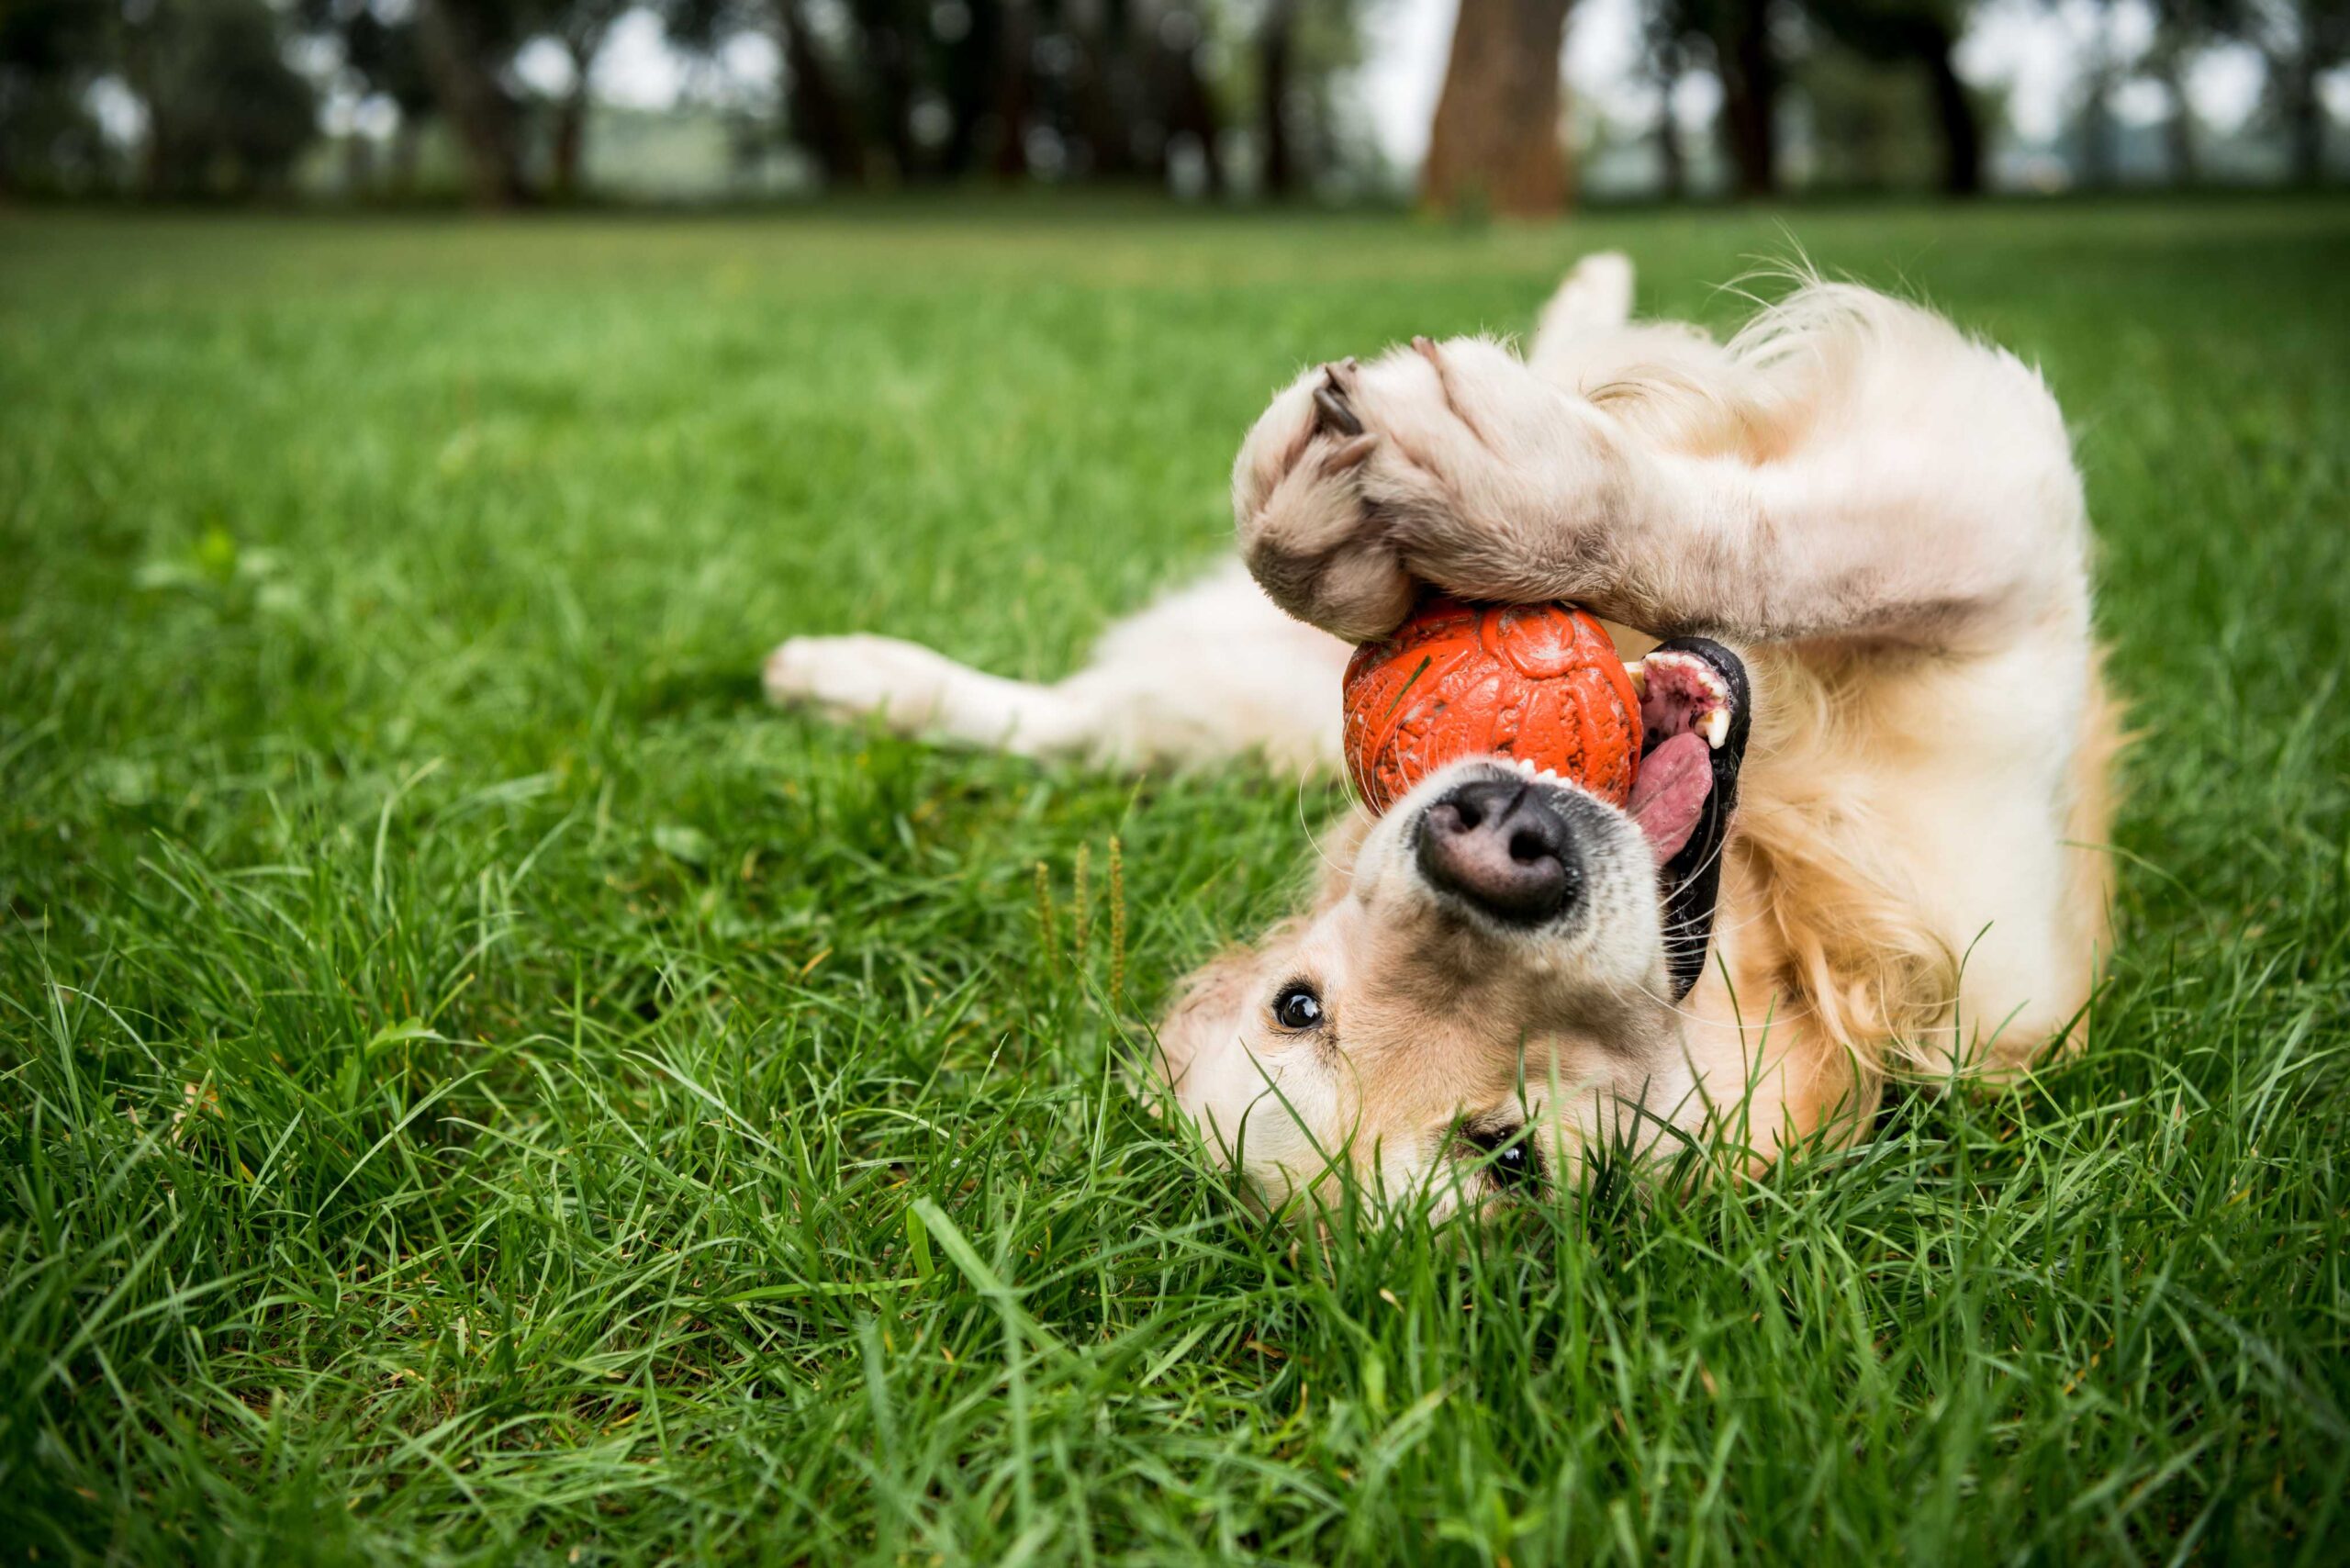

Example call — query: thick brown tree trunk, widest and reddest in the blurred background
[1419,0,1570,217]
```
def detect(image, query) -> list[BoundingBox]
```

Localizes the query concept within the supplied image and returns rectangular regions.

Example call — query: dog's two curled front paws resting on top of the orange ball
[1234,339,1591,642]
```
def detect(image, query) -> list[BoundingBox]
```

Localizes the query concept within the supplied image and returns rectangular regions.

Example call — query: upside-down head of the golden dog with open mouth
[1158,637,1751,1211]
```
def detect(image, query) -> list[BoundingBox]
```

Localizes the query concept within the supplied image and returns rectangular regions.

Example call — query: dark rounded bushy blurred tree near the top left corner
[118,0,318,197]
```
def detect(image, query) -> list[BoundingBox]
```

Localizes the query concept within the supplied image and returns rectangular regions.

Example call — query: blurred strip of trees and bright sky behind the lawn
[0,0,2350,214]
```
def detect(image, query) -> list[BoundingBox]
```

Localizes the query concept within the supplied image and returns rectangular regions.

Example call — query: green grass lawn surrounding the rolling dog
[0,202,2350,1565]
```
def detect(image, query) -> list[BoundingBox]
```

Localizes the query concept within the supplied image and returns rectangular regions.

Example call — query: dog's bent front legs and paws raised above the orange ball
[1234,286,2085,646]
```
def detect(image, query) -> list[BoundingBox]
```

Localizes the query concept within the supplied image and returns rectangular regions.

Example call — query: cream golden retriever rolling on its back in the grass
[767,254,2120,1215]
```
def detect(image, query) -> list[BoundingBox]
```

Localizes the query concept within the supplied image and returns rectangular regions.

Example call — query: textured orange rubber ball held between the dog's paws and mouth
[1344,597,1640,813]
